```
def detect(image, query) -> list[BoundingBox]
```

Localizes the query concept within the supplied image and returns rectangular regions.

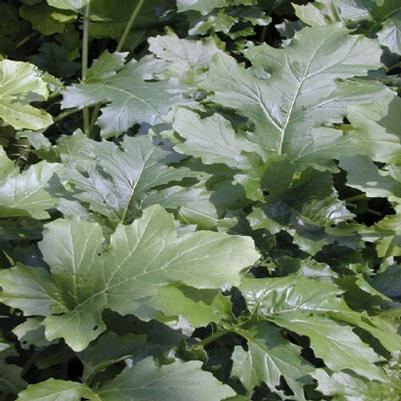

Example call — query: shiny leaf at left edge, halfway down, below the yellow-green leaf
[0,147,61,219]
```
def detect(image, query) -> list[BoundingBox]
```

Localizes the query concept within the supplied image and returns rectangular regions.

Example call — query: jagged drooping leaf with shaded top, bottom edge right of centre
[232,322,314,401]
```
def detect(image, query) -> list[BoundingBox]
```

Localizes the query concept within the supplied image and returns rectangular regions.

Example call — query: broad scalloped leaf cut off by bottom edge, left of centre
[97,358,235,401]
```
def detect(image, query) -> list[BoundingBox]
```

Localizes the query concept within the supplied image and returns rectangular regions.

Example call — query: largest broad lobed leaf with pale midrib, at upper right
[201,25,383,160]
